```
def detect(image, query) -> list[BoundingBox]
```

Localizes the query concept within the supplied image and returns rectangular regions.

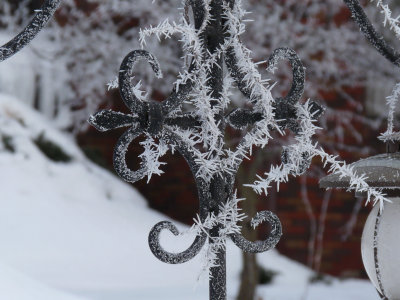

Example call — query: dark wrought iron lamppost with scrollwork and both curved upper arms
[0,0,400,300]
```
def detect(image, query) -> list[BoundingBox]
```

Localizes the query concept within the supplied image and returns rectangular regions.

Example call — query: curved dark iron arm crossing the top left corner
[0,0,61,62]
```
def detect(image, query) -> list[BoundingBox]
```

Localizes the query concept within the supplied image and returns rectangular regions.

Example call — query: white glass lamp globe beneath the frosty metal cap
[361,197,400,300]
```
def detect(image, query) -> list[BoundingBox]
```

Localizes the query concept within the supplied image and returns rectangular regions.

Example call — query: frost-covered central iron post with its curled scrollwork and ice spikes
[89,0,323,300]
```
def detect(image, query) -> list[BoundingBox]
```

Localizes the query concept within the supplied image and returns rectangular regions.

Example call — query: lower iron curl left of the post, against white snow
[149,221,207,264]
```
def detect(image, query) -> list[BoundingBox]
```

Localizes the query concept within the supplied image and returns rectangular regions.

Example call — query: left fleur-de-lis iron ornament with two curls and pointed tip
[89,50,198,183]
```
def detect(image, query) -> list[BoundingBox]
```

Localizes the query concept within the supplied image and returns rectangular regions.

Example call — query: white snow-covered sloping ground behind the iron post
[0,94,378,300]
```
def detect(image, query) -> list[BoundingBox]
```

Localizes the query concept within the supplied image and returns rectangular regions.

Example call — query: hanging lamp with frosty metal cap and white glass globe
[319,152,400,300]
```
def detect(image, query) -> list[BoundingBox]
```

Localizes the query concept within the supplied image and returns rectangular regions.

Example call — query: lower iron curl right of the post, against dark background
[230,211,282,253]
